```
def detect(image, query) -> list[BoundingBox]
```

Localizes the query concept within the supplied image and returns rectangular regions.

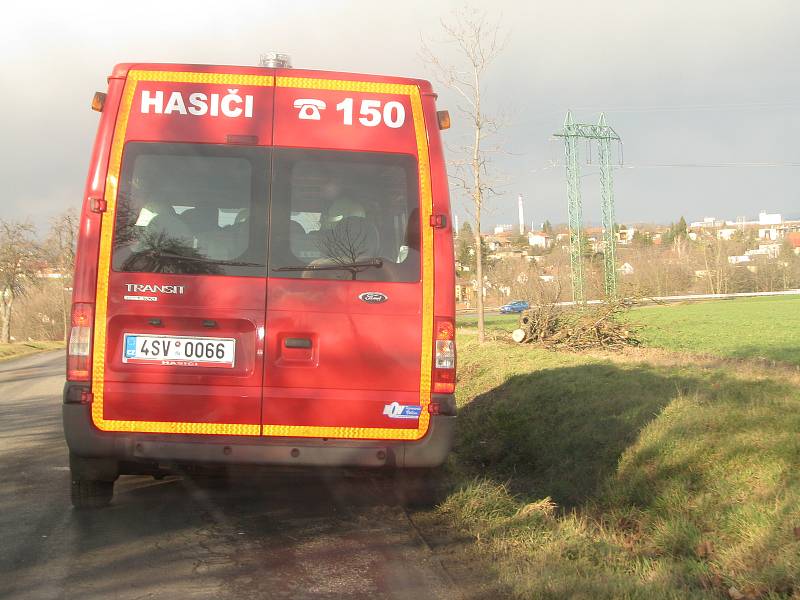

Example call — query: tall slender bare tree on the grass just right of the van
[422,9,504,342]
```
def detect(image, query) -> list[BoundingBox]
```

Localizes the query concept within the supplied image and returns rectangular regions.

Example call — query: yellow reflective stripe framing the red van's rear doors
[91,70,434,440]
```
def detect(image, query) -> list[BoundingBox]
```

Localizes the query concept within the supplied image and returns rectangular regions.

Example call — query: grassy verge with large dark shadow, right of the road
[439,334,800,598]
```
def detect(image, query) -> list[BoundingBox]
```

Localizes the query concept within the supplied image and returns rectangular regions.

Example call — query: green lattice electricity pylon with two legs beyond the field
[555,112,622,304]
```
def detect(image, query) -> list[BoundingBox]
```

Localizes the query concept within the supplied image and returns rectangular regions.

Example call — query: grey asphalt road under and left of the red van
[0,352,462,600]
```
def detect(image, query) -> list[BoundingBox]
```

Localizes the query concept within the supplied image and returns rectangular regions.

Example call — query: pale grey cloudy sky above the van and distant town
[0,0,800,232]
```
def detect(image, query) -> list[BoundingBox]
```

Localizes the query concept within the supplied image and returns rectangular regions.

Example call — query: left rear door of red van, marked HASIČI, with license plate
[92,67,274,435]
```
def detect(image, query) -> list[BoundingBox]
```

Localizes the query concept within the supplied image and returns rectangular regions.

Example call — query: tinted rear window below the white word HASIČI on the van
[112,142,269,277]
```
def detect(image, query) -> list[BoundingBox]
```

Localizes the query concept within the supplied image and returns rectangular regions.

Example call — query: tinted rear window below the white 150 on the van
[270,148,420,281]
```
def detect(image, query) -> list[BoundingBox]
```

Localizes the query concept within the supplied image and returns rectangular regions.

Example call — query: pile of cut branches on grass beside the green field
[511,300,641,350]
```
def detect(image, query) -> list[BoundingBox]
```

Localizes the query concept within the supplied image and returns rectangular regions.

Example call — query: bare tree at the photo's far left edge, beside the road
[0,220,39,344]
